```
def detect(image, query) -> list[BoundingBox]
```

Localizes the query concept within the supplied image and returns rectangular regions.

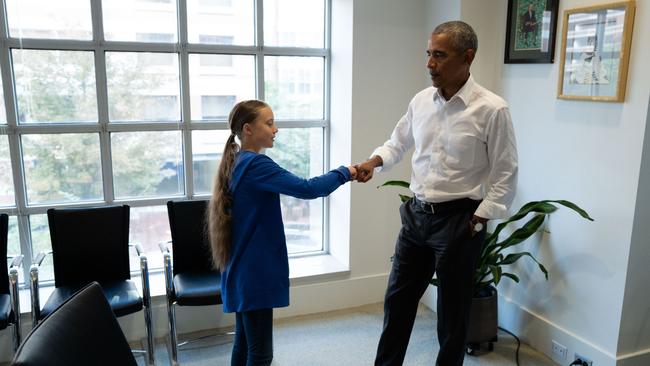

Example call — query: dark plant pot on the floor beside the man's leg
[467,286,498,348]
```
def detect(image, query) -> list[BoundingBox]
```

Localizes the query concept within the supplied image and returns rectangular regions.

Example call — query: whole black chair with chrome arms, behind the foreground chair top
[30,205,154,365]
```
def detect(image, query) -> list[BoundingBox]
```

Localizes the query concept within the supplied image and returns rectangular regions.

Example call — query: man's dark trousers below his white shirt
[375,199,485,366]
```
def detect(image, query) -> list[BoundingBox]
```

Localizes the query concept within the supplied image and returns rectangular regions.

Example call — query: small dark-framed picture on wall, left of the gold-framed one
[504,0,559,64]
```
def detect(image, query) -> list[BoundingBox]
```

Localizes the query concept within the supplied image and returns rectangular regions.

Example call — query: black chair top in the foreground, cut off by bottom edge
[12,282,137,366]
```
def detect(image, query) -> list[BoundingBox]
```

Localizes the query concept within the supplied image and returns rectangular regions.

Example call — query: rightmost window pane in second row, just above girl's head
[264,56,325,119]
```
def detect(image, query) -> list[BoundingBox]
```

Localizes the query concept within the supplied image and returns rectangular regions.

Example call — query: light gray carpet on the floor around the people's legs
[138,304,556,366]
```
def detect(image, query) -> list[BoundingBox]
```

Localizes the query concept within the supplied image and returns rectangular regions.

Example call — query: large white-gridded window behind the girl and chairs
[0,0,330,283]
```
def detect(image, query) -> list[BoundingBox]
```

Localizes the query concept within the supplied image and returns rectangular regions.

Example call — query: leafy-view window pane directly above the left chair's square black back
[22,133,103,204]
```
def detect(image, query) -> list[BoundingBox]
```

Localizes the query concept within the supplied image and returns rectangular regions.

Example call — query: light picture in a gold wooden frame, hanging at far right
[557,1,635,102]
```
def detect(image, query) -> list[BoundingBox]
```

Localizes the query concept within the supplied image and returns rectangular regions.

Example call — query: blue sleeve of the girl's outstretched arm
[247,154,350,199]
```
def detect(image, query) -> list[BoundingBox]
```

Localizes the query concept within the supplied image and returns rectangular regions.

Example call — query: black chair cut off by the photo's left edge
[0,214,23,351]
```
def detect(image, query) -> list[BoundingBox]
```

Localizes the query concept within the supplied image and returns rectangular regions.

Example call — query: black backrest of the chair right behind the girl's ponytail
[167,200,216,275]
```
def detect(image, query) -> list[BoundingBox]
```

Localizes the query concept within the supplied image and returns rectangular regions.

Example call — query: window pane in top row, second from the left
[102,0,178,43]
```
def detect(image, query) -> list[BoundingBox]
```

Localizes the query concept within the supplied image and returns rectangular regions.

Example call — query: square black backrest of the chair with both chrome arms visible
[47,205,131,287]
